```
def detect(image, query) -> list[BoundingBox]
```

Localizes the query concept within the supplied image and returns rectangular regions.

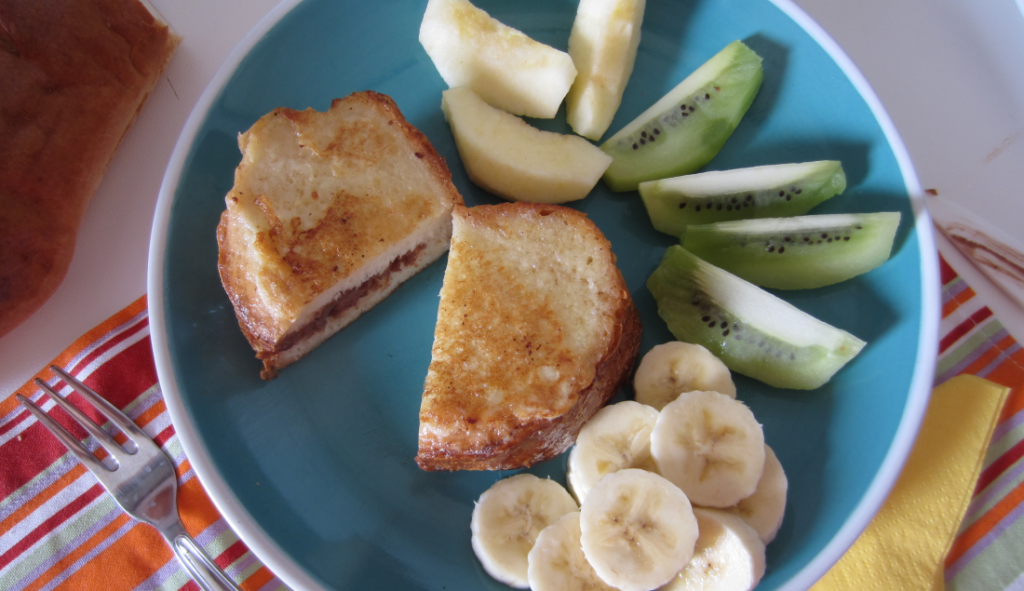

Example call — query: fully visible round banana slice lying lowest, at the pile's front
[580,468,697,591]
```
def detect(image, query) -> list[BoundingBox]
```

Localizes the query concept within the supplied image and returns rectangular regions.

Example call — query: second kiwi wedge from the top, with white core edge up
[640,160,846,237]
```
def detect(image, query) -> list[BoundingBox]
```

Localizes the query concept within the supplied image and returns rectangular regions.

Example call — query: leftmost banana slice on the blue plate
[470,473,579,589]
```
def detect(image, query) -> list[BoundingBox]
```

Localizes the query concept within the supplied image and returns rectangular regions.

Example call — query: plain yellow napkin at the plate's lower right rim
[811,375,1010,591]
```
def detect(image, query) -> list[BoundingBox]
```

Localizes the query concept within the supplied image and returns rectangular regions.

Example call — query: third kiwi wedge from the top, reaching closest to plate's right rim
[683,212,900,289]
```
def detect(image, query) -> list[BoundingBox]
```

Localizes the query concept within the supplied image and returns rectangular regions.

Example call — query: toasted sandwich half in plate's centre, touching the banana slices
[416,203,641,470]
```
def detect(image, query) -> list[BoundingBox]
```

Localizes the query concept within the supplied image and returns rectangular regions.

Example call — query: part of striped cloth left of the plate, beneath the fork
[0,297,287,591]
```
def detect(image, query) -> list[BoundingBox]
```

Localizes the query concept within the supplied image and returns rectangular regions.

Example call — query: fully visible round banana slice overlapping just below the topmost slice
[650,391,765,508]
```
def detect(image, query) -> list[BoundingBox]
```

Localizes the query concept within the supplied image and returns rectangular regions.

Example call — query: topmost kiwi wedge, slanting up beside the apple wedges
[601,41,764,192]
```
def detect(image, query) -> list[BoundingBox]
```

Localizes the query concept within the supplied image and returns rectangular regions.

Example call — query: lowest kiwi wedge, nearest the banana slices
[647,246,865,390]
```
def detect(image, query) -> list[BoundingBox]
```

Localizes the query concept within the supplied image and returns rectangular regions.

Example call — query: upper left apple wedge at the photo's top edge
[420,0,577,119]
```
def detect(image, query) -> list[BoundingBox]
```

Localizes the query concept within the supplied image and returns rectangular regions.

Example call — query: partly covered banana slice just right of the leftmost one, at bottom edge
[527,511,615,591]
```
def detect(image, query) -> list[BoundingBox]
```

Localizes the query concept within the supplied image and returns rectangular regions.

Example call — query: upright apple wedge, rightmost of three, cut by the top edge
[565,0,646,141]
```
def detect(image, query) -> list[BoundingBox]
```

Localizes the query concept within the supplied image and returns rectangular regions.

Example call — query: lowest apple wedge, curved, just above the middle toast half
[441,86,611,203]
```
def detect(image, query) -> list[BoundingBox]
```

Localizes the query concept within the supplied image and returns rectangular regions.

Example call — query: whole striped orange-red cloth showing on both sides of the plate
[0,250,1024,591]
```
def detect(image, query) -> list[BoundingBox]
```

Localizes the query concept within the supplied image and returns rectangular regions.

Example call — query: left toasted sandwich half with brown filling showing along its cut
[217,91,462,379]
